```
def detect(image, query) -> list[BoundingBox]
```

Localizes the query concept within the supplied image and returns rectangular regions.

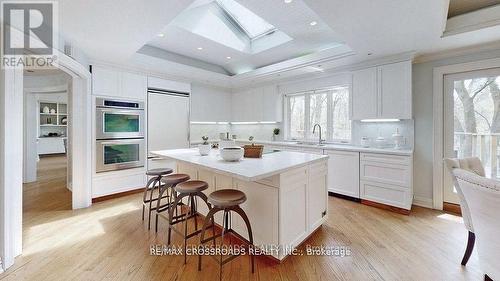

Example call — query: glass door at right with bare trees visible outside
[443,69,500,204]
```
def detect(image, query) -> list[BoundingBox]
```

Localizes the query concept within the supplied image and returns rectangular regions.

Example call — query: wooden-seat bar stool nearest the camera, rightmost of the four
[198,189,254,278]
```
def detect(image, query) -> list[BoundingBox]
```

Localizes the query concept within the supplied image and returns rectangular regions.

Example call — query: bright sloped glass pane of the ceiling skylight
[216,0,276,40]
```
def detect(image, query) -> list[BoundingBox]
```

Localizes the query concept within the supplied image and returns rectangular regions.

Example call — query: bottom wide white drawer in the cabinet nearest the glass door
[360,181,413,210]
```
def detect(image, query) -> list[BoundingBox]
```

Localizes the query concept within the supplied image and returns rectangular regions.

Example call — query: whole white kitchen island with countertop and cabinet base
[152,149,328,261]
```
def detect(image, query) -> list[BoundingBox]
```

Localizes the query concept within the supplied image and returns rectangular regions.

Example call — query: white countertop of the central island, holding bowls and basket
[151,148,328,181]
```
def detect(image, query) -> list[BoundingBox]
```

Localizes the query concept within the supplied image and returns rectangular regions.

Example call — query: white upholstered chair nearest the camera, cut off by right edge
[453,169,500,280]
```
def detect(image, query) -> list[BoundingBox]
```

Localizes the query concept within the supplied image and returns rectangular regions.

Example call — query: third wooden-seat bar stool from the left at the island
[167,180,211,264]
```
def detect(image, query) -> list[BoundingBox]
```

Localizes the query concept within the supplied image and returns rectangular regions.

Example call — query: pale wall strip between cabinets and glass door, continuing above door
[413,47,500,204]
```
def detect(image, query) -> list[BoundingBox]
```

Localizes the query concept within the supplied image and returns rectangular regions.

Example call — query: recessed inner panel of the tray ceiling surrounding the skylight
[147,0,342,75]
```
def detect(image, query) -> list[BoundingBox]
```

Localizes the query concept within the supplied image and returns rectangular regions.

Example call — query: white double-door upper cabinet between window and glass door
[351,61,412,120]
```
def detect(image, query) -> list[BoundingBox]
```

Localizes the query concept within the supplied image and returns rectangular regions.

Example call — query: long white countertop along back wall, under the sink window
[191,139,413,156]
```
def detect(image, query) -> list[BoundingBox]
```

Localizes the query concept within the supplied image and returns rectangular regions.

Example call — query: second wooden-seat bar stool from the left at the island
[155,174,190,232]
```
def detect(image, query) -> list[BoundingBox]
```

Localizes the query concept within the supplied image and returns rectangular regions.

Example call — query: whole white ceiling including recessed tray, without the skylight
[54,0,500,87]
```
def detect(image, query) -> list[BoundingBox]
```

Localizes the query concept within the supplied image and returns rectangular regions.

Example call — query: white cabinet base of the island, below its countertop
[177,161,328,259]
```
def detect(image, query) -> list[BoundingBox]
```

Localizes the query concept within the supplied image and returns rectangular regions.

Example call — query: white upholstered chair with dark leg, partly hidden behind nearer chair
[444,157,485,265]
